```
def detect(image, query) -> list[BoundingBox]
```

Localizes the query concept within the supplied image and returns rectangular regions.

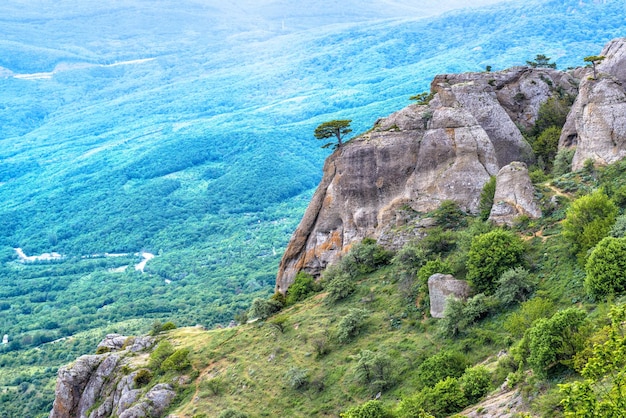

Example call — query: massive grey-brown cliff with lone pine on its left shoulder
[276,67,575,293]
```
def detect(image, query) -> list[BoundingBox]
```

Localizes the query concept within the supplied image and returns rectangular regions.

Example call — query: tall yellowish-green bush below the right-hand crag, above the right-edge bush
[563,190,617,265]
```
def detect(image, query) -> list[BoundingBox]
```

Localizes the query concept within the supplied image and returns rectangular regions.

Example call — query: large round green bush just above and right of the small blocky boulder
[467,229,525,295]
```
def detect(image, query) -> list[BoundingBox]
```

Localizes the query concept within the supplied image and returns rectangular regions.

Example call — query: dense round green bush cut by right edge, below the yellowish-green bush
[585,237,626,297]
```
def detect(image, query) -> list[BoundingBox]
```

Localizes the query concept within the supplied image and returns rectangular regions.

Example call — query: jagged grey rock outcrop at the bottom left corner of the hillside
[50,334,176,418]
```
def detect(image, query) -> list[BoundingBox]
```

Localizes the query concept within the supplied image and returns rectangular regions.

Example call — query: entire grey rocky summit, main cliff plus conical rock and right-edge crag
[276,38,626,293]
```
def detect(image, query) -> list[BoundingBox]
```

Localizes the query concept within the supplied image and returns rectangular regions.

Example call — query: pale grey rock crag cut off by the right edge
[559,38,626,171]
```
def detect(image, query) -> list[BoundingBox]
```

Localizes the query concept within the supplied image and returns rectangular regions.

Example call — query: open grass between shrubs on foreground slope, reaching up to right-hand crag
[140,163,626,417]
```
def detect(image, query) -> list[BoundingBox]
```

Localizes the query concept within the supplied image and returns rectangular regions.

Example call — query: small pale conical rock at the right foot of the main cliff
[489,161,541,226]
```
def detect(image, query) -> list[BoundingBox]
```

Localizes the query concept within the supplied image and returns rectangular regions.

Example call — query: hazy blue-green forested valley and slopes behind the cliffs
[0,1,625,416]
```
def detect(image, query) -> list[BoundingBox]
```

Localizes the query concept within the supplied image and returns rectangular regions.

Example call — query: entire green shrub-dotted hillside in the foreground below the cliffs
[88,155,626,418]
